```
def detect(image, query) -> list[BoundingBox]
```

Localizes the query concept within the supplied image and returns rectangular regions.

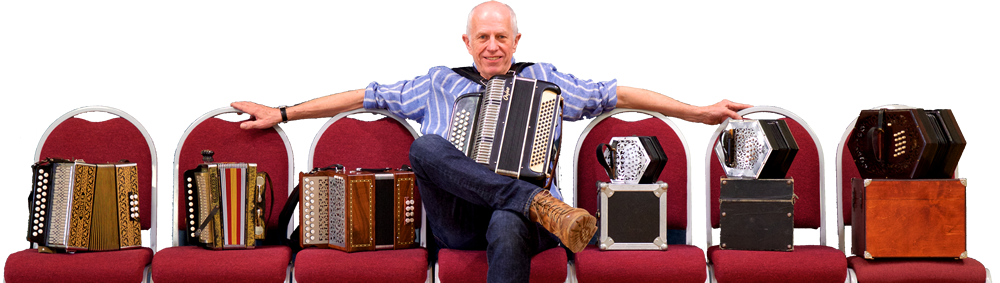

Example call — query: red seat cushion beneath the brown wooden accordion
[294,248,428,283]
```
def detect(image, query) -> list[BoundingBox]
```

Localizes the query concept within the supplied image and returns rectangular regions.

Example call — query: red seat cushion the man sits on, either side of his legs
[438,247,567,283]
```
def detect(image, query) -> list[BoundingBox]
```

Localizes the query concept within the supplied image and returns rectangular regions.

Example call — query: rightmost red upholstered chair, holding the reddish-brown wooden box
[836,105,989,283]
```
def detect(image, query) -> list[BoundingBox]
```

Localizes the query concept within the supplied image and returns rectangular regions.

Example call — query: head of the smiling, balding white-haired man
[462,1,521,79]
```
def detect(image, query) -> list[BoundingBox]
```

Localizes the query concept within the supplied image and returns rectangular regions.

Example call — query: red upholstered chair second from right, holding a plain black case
[705,106,848,282]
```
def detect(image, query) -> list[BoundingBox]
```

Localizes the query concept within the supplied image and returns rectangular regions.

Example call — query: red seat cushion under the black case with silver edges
[573,245,708,283]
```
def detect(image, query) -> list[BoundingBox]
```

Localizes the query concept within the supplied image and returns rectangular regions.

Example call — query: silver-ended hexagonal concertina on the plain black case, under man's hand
[715,119,799,179]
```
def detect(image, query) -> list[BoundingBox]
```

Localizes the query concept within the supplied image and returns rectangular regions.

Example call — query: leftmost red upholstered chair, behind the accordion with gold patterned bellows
[3,106,157,283]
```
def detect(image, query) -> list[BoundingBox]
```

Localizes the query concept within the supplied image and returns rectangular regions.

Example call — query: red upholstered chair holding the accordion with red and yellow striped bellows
[152,107,294,283]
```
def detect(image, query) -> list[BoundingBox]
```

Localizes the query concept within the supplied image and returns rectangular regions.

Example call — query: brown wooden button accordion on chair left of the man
[299,167,420,252]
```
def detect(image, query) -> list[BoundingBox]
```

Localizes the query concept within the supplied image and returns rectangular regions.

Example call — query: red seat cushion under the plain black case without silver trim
[706,245,847,283]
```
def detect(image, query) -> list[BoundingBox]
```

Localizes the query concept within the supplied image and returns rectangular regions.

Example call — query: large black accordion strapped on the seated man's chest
[447,75,562,187]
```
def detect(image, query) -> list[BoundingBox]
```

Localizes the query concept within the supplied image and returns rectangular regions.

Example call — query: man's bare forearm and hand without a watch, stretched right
[612,85,752,125]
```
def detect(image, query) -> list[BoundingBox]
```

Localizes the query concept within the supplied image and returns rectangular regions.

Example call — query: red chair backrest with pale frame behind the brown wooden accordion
[306,109,427,247]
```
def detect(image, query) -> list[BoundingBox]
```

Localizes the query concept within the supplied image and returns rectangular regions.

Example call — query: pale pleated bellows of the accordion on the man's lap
[472,80,506,164]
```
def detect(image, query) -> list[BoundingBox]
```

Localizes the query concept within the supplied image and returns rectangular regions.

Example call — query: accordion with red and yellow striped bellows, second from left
[183,153,269,250]
